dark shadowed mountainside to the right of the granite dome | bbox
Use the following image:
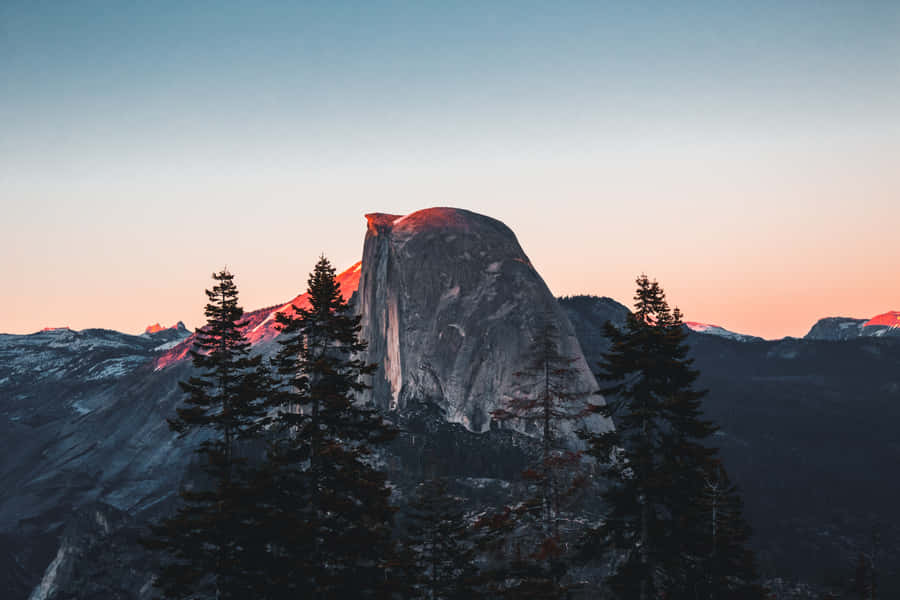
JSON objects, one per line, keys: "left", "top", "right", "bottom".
{"left": 560, "top": 297, "right": 900, "bottom": 598}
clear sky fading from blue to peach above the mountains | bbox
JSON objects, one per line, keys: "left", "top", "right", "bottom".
{"left": 0, "top": 0, "right": 900, "bottom": 338}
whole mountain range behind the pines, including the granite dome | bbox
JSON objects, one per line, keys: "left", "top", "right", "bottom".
{"left": 7, "top": 208, "right": 900, "bottom": 600}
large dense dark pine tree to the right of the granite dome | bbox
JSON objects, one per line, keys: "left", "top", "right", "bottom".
{"left": 582, "top": 275, "right": 761, "bottom": 600}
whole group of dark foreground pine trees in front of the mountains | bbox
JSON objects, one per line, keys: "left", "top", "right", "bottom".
{"left": 142, "top": 257, "right": 765, "bottom": 600}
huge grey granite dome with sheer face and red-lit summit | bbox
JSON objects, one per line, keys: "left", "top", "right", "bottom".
{"left": 357, "top": 208, "right": 609, "bottom": 432}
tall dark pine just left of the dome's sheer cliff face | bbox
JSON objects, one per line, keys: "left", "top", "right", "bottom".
{"left": 267, "top": 257, "right": 394, "bottom": 598}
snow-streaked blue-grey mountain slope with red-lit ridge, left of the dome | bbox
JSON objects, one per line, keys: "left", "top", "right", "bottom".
{"left": 0, "top": 264, "right": 359, "bottom": 600}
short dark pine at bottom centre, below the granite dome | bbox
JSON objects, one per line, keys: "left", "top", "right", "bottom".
{"left": 404, "top": 479, "right": 477, "bottom": 600}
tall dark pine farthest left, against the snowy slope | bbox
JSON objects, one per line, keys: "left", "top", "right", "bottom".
{"left": 142, "top": 269, "right": 268, "bottom": 599}
